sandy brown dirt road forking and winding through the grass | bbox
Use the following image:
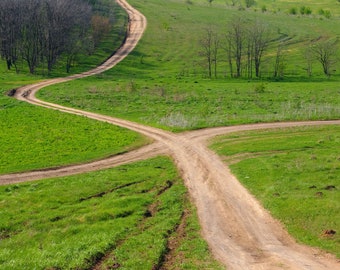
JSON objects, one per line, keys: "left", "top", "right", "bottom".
{"left": 0, "top": 0, "right": 340, "bottom": 270}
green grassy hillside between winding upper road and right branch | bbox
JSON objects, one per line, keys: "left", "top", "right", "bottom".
{"left": 38, "top": 0, "right": 340, "bottom": 131}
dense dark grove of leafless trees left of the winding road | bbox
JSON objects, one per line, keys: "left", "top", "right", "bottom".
{"left": 0, "top": 0, "right": 114, "bottom": 73}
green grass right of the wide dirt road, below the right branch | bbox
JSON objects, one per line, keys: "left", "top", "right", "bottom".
{"left": 212, "top": 126, "right": 340, "bottom": 257}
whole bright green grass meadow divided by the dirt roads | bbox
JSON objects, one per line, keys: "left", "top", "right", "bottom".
{"left": 0, "top": 0, "right": 340, "bottom": 269}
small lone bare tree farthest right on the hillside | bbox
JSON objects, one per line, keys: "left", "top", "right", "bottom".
{"left": 312, "top": 40, "right": 338, "bottom": 77}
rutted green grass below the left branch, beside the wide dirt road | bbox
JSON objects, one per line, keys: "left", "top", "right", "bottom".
{"left": 0, "top": 157, "right": 222, "bottom": 269}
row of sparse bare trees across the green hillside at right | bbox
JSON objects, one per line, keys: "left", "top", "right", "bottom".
{"left": 199, "top": 16, "right": 338, "bottom": 79}
